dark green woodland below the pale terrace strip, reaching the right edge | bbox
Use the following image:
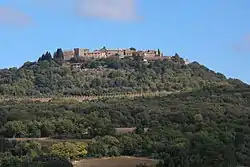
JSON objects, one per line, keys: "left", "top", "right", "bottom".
{"left": 0, "top": 85, "right": 250, "bottom": 167}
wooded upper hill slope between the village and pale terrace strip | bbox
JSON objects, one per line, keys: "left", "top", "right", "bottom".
{"left": 0, "top": 52, "right": 243, "bottom": 97}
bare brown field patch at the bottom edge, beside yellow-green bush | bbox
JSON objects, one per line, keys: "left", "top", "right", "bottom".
{"left": 74, "top": 157, "right": 158, "bottom": 167}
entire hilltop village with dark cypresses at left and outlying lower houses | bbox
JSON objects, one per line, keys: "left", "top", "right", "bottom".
{"left": 38, "top": 47, "right": 190, "bottom": 70}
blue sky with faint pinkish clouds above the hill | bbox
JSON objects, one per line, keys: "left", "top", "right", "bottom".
{"left": 0, "top": 0, "right": 250, "bottom": 83}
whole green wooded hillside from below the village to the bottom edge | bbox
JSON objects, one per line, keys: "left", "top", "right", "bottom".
{"left": 0, "top": 56, "right": 250, "bottom": 167}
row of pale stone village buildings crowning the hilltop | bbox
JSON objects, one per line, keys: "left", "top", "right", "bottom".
{"left": 63, "top": 47, "right": 171, "bottom": 61}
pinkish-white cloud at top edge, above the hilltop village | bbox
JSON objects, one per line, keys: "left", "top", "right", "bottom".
{"left": 76, "top": 0, "right": 138, "bottom": 21}
